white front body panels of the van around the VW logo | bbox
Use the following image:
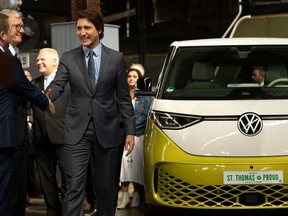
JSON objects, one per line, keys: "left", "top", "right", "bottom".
{"left": 153, "top": 99, "right": 288, "bottom": 157}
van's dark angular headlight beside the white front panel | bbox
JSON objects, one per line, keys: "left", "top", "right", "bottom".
{"left": 150, "top": 110, "right": 202, "bottom": 130}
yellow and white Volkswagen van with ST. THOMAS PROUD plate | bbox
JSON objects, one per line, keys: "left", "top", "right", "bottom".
{"left": 144, "top": 38, "right": 288, "bottom": 213}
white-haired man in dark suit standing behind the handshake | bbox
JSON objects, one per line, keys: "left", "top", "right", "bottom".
{"left": 32, "top": 48, "right": 70, "bottom": 216}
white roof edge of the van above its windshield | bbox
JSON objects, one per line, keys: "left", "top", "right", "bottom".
{"left": 170, "top": 37, "right": 288, "bottom": 47}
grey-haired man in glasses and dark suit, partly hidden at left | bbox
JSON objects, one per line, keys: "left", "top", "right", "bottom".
{"left": 0, "top": 9, "right": 28, "bottom": 216}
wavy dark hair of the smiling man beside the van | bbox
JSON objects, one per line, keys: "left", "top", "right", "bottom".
{"left": 76, "top": 9, "right": 104, "bottom": 40}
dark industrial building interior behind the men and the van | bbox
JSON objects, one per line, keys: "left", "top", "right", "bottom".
{"left": 5, "top": 0, "right": 288, "bottom": 81}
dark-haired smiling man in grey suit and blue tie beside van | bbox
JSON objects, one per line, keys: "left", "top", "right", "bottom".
{"left": 48, "top": 10, "right": 135, "bottom": 216}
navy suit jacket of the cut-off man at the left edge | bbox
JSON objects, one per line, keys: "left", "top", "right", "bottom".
{"left": 0, "top": 51, "right": 49, "bottom": 148}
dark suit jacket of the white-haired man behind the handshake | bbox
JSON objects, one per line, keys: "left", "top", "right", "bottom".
{"left": 32, "top": 76, "right": 70, "bottom": 145}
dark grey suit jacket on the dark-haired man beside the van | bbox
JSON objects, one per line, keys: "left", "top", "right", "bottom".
{"left": 48, "top": 45, "right": 135, "bottom": 148}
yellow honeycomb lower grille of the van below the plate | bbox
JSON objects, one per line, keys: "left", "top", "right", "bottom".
{"left": 155, "top": 169, "right": 288, "bottom": 209}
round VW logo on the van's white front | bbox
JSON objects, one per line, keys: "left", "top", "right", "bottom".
{"left": 238, "top": 113, "right": 263, "bottom": 136}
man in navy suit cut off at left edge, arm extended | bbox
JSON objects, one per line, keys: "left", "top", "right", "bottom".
{"left": 0, "top": 14, "right": 54, "bottom": 216}
